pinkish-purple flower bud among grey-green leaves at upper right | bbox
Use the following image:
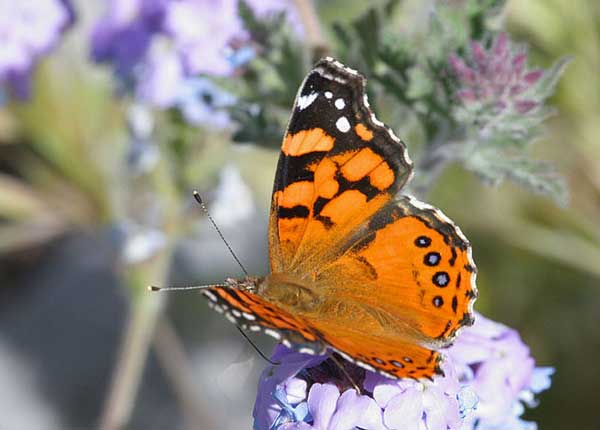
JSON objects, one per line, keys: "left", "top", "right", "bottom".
{"left": 449, "top": 33, "right": 544, "bottom": 114}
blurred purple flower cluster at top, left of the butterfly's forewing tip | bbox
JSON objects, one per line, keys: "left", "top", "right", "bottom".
{"left": 91, "top": 0, "right": 297, "bottom": 115}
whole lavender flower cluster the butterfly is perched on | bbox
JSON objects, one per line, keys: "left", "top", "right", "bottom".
{"left": 254, "top": 315, "right": 554, "bottom": 430}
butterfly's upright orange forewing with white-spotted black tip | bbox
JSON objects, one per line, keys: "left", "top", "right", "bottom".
{"left": 269, "top": 58, "right": 412, "bottom": 276}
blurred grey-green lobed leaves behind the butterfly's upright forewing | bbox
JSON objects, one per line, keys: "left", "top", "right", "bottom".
{"left": 223, "top": 0, "right": 567, "bottom": 204}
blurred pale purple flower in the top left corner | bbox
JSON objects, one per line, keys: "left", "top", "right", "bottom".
{"left": 0, "top": 0, "right": 74, "bottom": 99}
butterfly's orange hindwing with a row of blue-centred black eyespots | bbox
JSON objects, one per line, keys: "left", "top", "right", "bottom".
{"left": 305, "top": 196, "right": 477, "bottom": 378}
